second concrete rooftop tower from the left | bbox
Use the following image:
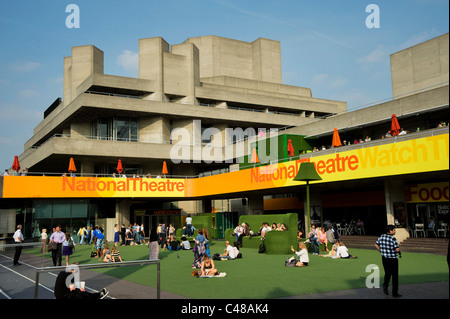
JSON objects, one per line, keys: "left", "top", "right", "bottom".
{"left": 139, "top": 37, "right": 169, "bottom": 101}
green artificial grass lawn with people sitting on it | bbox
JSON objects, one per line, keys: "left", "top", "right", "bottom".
{"left": 30, "top": 241, "right": 449, "bottom": 299}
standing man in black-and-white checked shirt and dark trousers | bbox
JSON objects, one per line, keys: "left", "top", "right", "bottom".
{"left": 375, "top": 225, "right": 402, "bottom": 297}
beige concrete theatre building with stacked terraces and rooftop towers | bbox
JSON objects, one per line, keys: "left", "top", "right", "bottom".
{"left": 0, "top": 34, "right": 449, "bottom": 242}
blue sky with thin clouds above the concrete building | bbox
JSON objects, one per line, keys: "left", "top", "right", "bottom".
{"left": 0, "top": 0, "right": 449, "bottom": 171}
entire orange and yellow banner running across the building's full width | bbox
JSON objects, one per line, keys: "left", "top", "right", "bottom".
{"left": 3, "top": 134, "right": 449, "bottom": 200}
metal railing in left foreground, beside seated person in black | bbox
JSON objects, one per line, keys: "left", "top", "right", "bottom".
{"left": 34, "top": 259, "right": 161, "bottom": 299}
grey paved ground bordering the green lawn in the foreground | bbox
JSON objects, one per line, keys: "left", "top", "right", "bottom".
{"left": 0, "top": 252, "right": 449, "bottom": 300}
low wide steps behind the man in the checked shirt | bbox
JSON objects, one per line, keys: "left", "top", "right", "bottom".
{"left": 340, "top": 236, "right": 448, "bottom": 256}
